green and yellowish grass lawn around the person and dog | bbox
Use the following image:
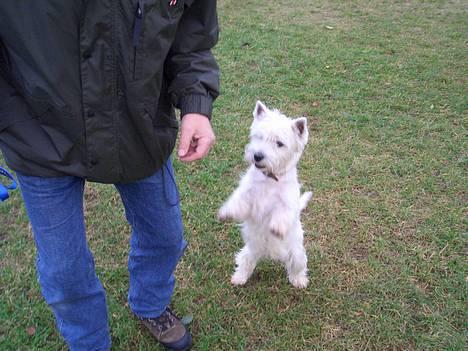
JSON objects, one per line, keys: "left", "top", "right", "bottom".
{"left": 0, "top": 0, "right": 468, "bottom": 351}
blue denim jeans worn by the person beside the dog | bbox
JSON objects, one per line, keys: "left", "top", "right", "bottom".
{"left": 17, "top": 161, "right": 186, "bottom": 351}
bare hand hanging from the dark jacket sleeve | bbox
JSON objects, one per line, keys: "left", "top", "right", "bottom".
{"left": 177, "top": 113, "right": 215, "bottom": 162}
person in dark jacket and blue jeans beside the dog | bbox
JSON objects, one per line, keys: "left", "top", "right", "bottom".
{"left": 0, "top": 0, "right": 219, "bottom": 351}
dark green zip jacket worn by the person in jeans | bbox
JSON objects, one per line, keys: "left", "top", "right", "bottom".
{"left": 0, "top": 0, "right": 219, "bottom": 183}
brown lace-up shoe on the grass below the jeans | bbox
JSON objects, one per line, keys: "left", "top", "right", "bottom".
{"left": 138, "top": 307, "right": 192, "bottom": 351}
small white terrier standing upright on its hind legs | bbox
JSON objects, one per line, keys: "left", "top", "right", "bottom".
{"left": 218, "top": 101, "right": 312, "bottom": 288}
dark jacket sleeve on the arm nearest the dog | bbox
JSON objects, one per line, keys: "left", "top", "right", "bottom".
{"left": 165, "top": 0, "right": 219, "bottom": 118}
